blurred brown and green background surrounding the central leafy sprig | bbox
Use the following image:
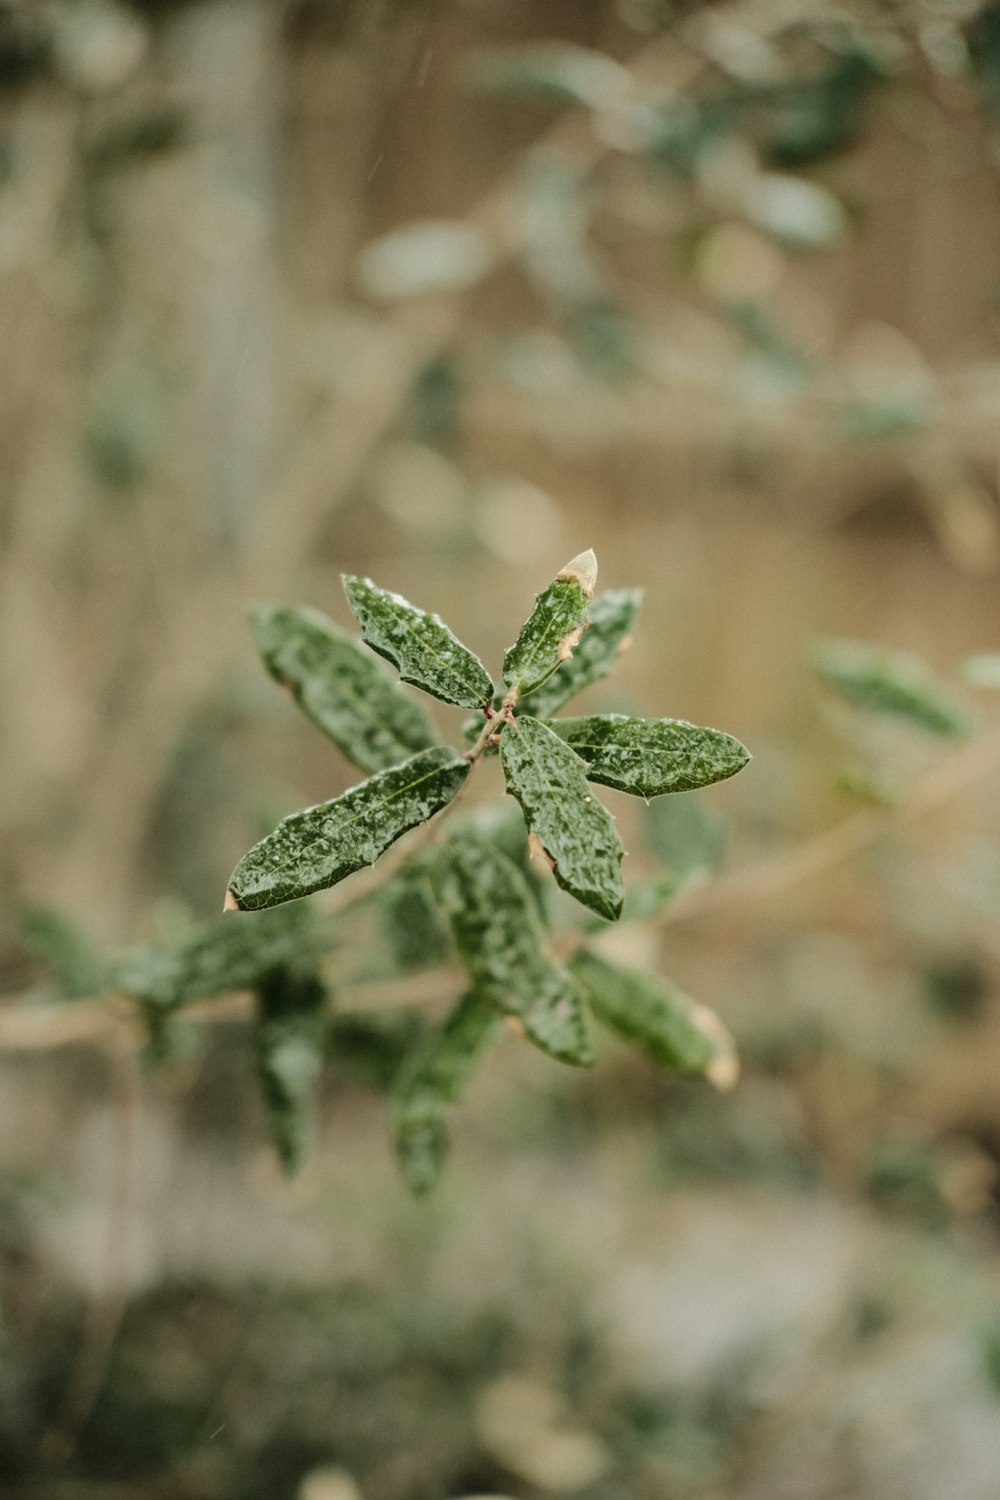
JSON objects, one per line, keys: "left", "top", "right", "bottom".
{"left": 0, "top": 0, "right": 1000, "bottom": 1500}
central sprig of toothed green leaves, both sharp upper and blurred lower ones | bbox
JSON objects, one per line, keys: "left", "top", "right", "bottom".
{"left": 117, "top": 552, "right": 748, "bottom": 1190}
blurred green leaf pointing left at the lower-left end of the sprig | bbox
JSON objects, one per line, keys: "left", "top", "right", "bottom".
{"left": 109, "top": 906, "right": 312, "bottom": 1010}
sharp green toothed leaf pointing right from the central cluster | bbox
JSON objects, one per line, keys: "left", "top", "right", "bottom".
{"left": 549, "top": 714, "right": 750, "bottom": 801}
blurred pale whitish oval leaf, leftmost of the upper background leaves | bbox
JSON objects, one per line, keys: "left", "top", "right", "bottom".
{"left": 357, "top": 219, "right": 493, "bottom": 302}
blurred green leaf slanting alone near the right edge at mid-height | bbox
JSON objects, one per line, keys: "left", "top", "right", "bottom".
{"left": 813, "top": 641, "right": 972, "bottom": 738}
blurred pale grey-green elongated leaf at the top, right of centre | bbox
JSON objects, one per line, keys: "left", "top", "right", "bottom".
{"left": 471, "top": 42, "right": 633, "bottom": 110}
